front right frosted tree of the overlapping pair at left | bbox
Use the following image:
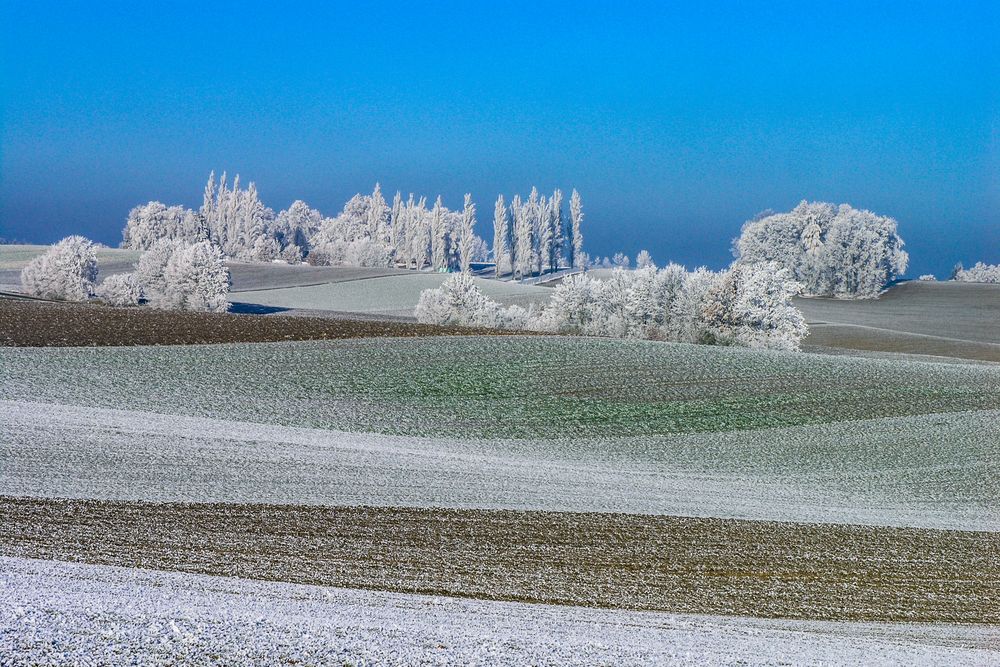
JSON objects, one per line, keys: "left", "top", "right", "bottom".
{"left": 163, "top": 241, "right": 230, "bottom": 313}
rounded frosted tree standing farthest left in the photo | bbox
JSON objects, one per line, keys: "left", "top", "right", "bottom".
{"left": 21, "top": 236, "right": 97, "bottom": 301}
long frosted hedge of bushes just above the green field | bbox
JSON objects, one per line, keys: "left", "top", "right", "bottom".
{"left": 416, "top": 263, "right": 807, "bottom": 350}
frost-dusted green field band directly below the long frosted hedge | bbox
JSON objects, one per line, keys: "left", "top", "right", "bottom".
{"left": 0, "top": 336, "right": 1000, "bottom": 439}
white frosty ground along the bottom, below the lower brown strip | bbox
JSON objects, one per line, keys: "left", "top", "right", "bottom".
{"left": 0, "top": 558, "right": 1000, "bottom": 667}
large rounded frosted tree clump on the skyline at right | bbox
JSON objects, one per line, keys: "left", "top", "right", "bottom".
{"left": 734, "top": 201, "right": 909, "bottom": 298}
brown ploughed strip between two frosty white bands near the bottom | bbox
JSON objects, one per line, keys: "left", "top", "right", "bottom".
{"left": 0, "top": 497, "right": 1000, "bottom": 623}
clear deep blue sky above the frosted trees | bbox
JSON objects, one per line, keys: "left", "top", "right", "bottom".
{"left": 0, "top": 0, "right": 1000, "bottom": 275}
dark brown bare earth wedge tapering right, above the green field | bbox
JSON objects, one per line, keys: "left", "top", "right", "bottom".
{"left": 0, "top": 298, "right": 502, "bottom": 347}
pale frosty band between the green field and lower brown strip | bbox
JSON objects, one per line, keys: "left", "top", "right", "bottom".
{"left": 0, "top": 401, "right": 1000, "bottom": 530}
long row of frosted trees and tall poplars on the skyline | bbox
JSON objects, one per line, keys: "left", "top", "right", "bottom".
{"left": 122, "top": 172, "right": 587, "bottom": 278}
